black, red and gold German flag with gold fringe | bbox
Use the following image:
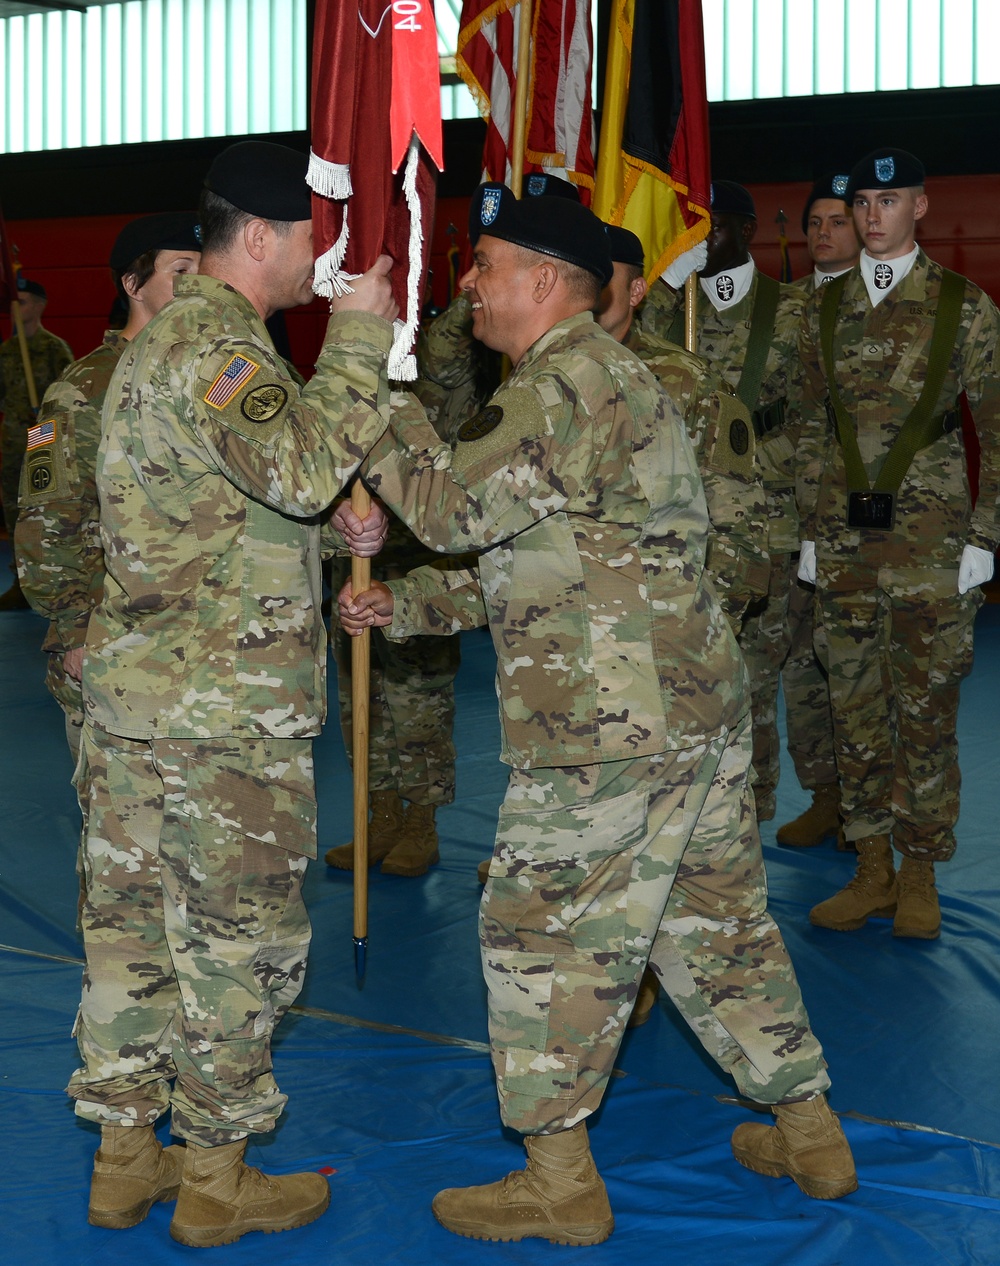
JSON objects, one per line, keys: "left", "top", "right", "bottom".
{"left": 594, "top": 0, "right": 711, "bottom": 279}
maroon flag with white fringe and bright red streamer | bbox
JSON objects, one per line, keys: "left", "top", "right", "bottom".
{"left": 309, "top": 0, "right": 443, "bottom": 379}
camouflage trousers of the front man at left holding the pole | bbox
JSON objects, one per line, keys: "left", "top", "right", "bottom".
{"left": 68, "top": 724, "right": 316, "bottom": 1146}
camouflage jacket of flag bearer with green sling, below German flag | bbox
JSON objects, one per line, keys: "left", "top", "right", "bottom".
{"left": 639, "top": 273, "right": 804, "bottom": 553}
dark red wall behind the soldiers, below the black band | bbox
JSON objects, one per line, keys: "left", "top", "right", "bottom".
{"left": 3, "top": 175, "right": 1000, "bottom": 371}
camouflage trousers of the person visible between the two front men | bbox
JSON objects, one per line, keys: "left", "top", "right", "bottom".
{"left": 335, "top": 617, "right": 461, "bottom": 805}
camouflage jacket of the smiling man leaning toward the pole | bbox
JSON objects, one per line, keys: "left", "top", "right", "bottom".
{"left": 366, "top": 314, "right": 748, "bottom": 767}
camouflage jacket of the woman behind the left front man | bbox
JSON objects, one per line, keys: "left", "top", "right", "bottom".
{"left": 16, "top": 329, "right": 127, "bottom": 651}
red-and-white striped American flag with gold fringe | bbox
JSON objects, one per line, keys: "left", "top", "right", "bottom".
{"left": 456, "top": 0, "right": 594, "bottom": 204}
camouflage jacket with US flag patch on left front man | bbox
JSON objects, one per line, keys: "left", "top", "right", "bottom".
{"left": 84, "top": 276, "right": 391, "bottom": 738}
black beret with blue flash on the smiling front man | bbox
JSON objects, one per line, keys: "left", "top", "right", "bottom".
{"left": 468, "top": 184, "right": 614, "bottom": 286}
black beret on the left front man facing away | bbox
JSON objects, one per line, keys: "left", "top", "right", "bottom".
{"left": 205, "top": 141, "right": 313, "bottom": 220}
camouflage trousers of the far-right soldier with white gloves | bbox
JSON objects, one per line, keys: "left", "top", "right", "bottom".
{"left": 815, "top": 568, "right": 982, "bottom": 861}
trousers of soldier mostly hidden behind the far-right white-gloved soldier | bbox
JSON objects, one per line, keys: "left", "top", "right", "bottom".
{"left": 781, "top": 572, "right": 837, "bottom": 791}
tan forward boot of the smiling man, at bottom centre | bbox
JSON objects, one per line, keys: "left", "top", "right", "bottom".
{"left": 432, "top": 1122, "right": 615, "bottom": 1244}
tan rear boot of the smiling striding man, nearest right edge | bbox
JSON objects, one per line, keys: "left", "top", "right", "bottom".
{"left": 733, "top": 1095, "right": 858, "bottom": 1200}
